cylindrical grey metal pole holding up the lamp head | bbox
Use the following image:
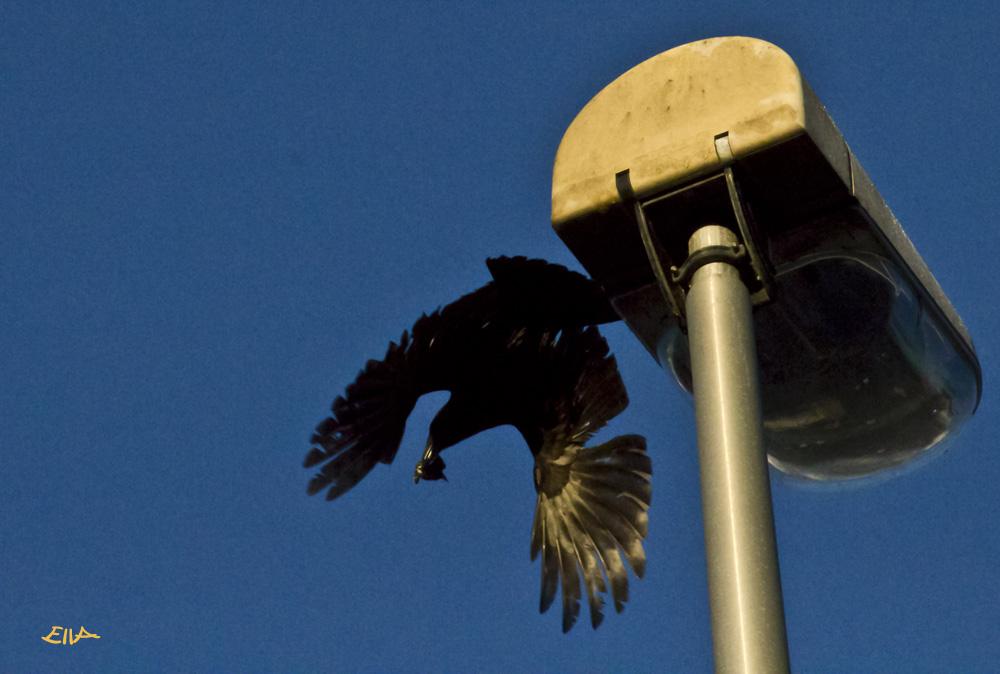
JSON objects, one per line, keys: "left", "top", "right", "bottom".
{"left": 686, "top": 225, "right": 790, "bottom": 674}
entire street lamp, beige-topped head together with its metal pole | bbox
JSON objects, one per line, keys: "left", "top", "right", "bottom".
{"left": 552, "top": 37, "right": 982, "bottom": 672}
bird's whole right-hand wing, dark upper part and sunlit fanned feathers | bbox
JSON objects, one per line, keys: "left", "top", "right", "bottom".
{"left": 531, "top": 329, "right": 653, "bottom": 632}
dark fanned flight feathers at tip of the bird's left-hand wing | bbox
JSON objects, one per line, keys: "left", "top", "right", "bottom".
{"left": 304, "top": 332, "right": 417, "bottom": 501}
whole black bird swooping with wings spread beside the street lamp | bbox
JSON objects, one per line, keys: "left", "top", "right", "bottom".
{"left": 305, "top": 257, "right": 652, "bottom": 632}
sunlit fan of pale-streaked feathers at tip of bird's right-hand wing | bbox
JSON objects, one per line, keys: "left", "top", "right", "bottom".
{"left": 531, "top": 435, "right": 653, "bottom": 632}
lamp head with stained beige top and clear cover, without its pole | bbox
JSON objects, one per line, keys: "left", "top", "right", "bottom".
{"left": 552, "top": 37, "right": 982, "bottom": 480}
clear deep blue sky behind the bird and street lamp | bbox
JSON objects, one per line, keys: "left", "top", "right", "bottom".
{"left": 0, "top": 0, "right": 1000, "bottom": 672}
